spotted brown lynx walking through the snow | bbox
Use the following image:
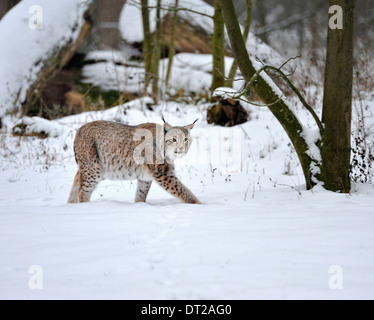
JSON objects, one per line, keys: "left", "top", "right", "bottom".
{"left": 68, "top": 120, "right": 200, "bottom": 204}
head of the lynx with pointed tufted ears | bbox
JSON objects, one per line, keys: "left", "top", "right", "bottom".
{"left": 162, "top": 118, "right": 197, "bottom": 160}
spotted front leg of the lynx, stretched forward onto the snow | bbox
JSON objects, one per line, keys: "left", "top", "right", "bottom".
{"left": 155, "top": 175, "right": 201, "bottom": 204}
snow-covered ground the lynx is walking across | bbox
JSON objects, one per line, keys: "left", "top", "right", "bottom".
{"left": 0, "top": 99, "right": 374, "bottom": 299}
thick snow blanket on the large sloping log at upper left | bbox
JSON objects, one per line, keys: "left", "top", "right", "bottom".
{"left": 0, "top": 0, "right": 91, "bottom": 118}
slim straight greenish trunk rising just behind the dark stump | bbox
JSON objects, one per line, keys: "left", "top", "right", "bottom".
{"left": 211, "top": 0, "right": 225, "bottom": 97}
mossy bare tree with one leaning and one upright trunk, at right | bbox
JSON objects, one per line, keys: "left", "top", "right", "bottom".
{"left": 219, "top": 0, "right": 355, "bottom": 192}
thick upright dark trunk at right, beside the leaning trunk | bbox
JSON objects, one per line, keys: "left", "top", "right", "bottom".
{"left": 322, "top": 0, "right": 355, "bottom": 192}
